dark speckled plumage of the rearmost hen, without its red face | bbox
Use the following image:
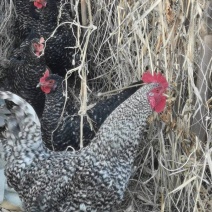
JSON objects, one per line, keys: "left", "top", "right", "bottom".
{"left": 14, "top": 0, "right": 79, "bottom": 76}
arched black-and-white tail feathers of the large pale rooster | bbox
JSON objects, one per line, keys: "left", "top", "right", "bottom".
{"left": 0, "top": 91, "right": 48, "bottom": 189}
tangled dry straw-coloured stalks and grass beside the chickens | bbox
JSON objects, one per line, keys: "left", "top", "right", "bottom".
{"left": 0, "top": 0, "right": 212, "bottom": 212}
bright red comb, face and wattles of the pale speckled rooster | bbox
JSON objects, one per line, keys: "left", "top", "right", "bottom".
{"left": 142, "top": 71, "right": 168, "bottom": 113}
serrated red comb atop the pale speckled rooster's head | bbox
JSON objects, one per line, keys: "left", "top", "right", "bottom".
{"left": 141, "top": 71, "right": 168, "bottom": 89}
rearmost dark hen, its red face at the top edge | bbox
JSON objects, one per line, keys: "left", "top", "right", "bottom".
{"left": 30, "top": 0, "right": 79, "bottom": 76}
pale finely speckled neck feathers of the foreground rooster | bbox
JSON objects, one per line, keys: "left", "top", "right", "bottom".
{"left": 82, "top": 84, "right": 157, "bottom": 164}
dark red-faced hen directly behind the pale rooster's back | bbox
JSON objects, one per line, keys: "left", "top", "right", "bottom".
{"left": 39, "top": 71, "right": 141, "bottom": 151}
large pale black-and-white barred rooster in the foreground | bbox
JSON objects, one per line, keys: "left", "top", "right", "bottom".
{"left": 0, "top": 73, "right": 168, "bottom": 212}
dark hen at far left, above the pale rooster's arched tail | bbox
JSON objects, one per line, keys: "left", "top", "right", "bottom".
{"left": 1, "top": 33, "right": 46, "bottom": 117}
